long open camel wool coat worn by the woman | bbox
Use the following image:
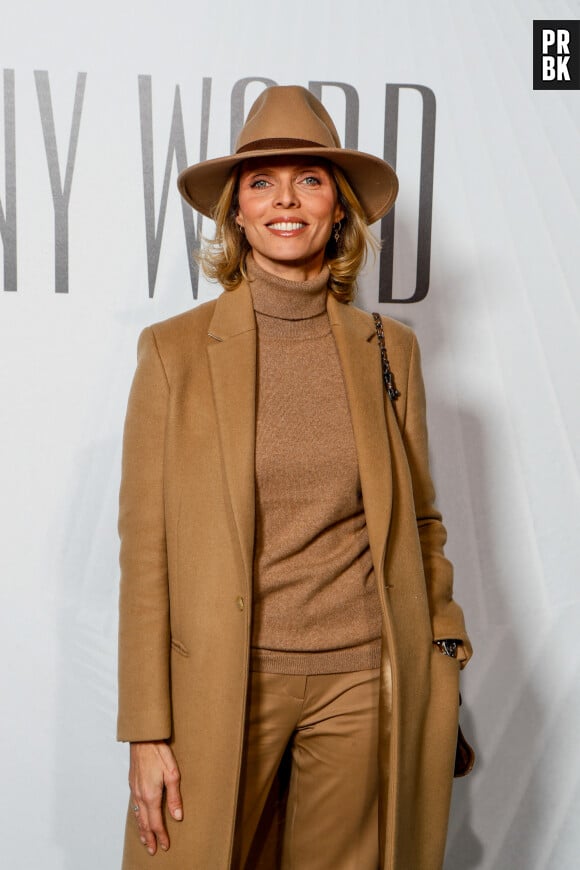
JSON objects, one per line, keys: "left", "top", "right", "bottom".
{"left": 118, "top": 283, "right": 471, "bottom": 870}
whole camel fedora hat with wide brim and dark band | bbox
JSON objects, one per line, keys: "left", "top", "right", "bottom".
{"left": 177, "top": 85, "right": 399, "bottom": 224}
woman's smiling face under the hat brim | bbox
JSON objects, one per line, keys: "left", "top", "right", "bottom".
{"left": 236, "top": 157, "right": 344, "bottom": 281}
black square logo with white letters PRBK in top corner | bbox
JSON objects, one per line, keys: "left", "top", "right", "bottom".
{"left": 534, "top": 21, "right": 580, "bottom": 91}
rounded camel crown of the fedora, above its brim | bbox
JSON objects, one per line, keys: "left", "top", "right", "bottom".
{"left": 235, "top": 85, "right": 341, "bottom": 153}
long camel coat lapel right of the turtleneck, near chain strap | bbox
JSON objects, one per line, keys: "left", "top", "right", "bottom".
{"left": 327, "top": 294, "right": 392, "bottom": 578}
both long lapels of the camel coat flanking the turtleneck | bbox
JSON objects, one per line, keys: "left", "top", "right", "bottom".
{"left": 208, "top": 282, "right": 392, "bottom": 589}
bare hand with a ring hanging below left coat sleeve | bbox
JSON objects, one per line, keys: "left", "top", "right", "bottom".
{"left": 129, "top": 740, "right": 183, "bottom": 855}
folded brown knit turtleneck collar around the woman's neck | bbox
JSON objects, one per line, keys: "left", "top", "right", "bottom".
{"left": 246, "top": 255, "right": 330, "bottom": 320}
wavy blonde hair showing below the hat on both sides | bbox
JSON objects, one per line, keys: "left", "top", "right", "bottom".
{"left": 197, "top": 160, "right": 380, "bottom": 303}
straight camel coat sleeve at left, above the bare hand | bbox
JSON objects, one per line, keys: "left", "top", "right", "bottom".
{"left": 117, "top": 327, "right": 171, "bottom": 741}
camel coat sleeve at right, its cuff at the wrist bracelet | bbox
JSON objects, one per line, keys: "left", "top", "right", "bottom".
{"left": 402, "top": 336, "right": 472, "bottom": 665}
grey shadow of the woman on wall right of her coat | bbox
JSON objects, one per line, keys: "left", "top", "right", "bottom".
{"left": 408, "top": 262, "right": 547, "bottom": 870}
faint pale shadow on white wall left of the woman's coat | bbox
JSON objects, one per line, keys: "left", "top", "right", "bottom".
{"left": 52, "top": 441, "right": 128, "bottom": 870}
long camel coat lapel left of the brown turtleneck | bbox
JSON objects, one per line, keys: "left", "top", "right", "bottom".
{"left": 208, "top": 283, "right": 256, "bottom": 588}
